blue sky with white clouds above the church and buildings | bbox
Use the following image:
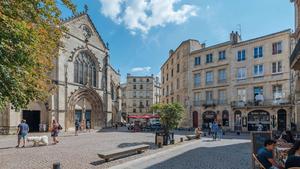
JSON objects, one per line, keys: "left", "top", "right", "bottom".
{"left": 63, "top": 0, "right": 294, "bottom": 82}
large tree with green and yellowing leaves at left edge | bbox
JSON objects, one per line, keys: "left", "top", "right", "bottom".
{"left": 0, "top": 0, "right": 76, "bottom": 110}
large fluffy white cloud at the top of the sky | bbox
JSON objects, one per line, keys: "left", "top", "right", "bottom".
{"left": 99, "top": 0, "right": 197, "bottom": 35}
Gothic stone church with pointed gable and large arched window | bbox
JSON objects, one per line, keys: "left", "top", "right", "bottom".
{"left": 0, "top": 11, "right": 121, "bottom": 134}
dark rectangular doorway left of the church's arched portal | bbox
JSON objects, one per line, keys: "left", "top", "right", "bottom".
{"left": 22, "top": 110, "right": 41, "bottom": 132}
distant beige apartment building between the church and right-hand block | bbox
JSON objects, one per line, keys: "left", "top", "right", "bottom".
{"left": 121, "top": 74, "right": 160, "bottom": 116}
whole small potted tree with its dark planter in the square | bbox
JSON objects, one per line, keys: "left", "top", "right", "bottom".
{"left": 151, "top": 103, "right": 184, "bottom": 145}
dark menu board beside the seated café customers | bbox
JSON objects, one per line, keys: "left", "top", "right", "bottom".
{"left": 251, "top": 131, "right": 272, "bottom": 154}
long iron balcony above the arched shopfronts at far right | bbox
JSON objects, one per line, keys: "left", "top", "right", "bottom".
{"left": 231, "top": 98, "right": 291, "bottom": 108}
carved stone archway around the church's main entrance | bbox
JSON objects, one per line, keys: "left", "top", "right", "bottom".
{"left": 65, "top": 87, "right": 106, "bottom": 130}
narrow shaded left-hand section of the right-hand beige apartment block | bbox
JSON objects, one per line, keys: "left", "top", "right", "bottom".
{"left": 161, "top": 39, "right": 201, "bottom": 127}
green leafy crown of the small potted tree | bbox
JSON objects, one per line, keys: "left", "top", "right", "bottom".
{"left": 151, "top": 103, "right": 184, "bottom": 133}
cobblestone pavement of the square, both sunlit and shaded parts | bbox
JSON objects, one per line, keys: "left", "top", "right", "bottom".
{"left": 0, "top": 129, "right": 250, "bottom": 169}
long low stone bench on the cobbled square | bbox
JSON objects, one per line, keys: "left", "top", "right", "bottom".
{"left": 98, "top": 144, "right": 150, "bottom": 162}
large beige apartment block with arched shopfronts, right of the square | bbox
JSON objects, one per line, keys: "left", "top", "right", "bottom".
{"left": 161, "top": 30, "right": 295, "bottom": 131}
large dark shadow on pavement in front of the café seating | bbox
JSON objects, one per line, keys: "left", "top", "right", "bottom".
{"left": 147, "top": 143, "right": 251, "bottom": 169}
